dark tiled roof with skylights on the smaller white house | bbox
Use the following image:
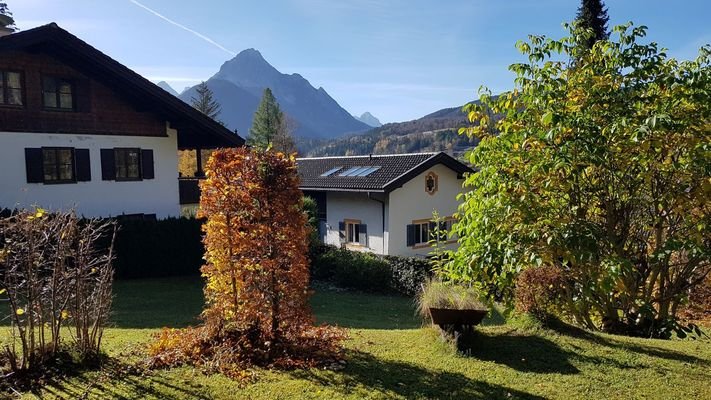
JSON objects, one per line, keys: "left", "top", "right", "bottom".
{"left": 296, "top": 153, "right": 472, "bottom": 192}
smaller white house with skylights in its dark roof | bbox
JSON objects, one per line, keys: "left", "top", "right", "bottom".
{"left": 297, "top": 153, "right": 472, "bottom": 256}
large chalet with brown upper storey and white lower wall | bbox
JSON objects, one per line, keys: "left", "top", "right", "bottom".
{"left": 0, "top": 23, "right": 244, "bottom": 218}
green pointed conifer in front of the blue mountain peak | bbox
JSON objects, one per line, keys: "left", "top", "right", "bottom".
{"left": 247, "top": 88, "right": 296, "bottom": 153}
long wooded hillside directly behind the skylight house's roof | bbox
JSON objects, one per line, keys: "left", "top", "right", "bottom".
{"left": 297, "top": 107, "right": 478, "bottom": 157}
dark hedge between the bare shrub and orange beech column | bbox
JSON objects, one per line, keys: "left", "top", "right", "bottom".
{"left": 114, "top": 218, "right": 205, "bottom": 278}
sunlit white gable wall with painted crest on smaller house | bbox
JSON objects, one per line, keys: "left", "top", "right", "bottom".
{"left": 388, "top": 164, "right": 463, "bottom": 256}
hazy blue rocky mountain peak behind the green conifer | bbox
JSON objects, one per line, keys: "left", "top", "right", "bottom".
{"left": 179, "top": 49, "right": 370, "bottom": 139}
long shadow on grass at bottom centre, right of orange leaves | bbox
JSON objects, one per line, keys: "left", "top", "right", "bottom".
{"left": 290, "top": 350, "right": 543, "bottom": 399}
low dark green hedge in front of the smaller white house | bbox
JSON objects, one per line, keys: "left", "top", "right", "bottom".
{"left": 311, "top": 246, "right": 431, "bottom": 296}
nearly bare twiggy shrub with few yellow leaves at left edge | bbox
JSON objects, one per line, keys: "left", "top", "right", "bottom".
{"left": 0, "top": 209, "right": 116, "bottom": 381}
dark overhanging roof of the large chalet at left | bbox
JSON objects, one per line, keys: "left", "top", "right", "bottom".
{"left": 0, "top": 23, "right": 244, "bottom": 148}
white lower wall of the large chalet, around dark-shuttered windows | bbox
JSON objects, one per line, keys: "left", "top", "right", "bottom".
{"left": 0, "top": 128, "right": 180, "bottom": 218}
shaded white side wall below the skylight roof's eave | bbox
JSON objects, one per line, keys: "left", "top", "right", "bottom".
{"left": 325, "top": 192, "right": 387, "bottom": 254}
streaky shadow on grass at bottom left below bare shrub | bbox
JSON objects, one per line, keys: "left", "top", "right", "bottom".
{"left": 31, "top": 358, "right": 207, "bottom": 399}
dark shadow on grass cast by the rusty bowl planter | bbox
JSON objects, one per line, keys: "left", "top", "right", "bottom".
{"left": 458, "top": 330, "right": 580, "bottom": 375}
